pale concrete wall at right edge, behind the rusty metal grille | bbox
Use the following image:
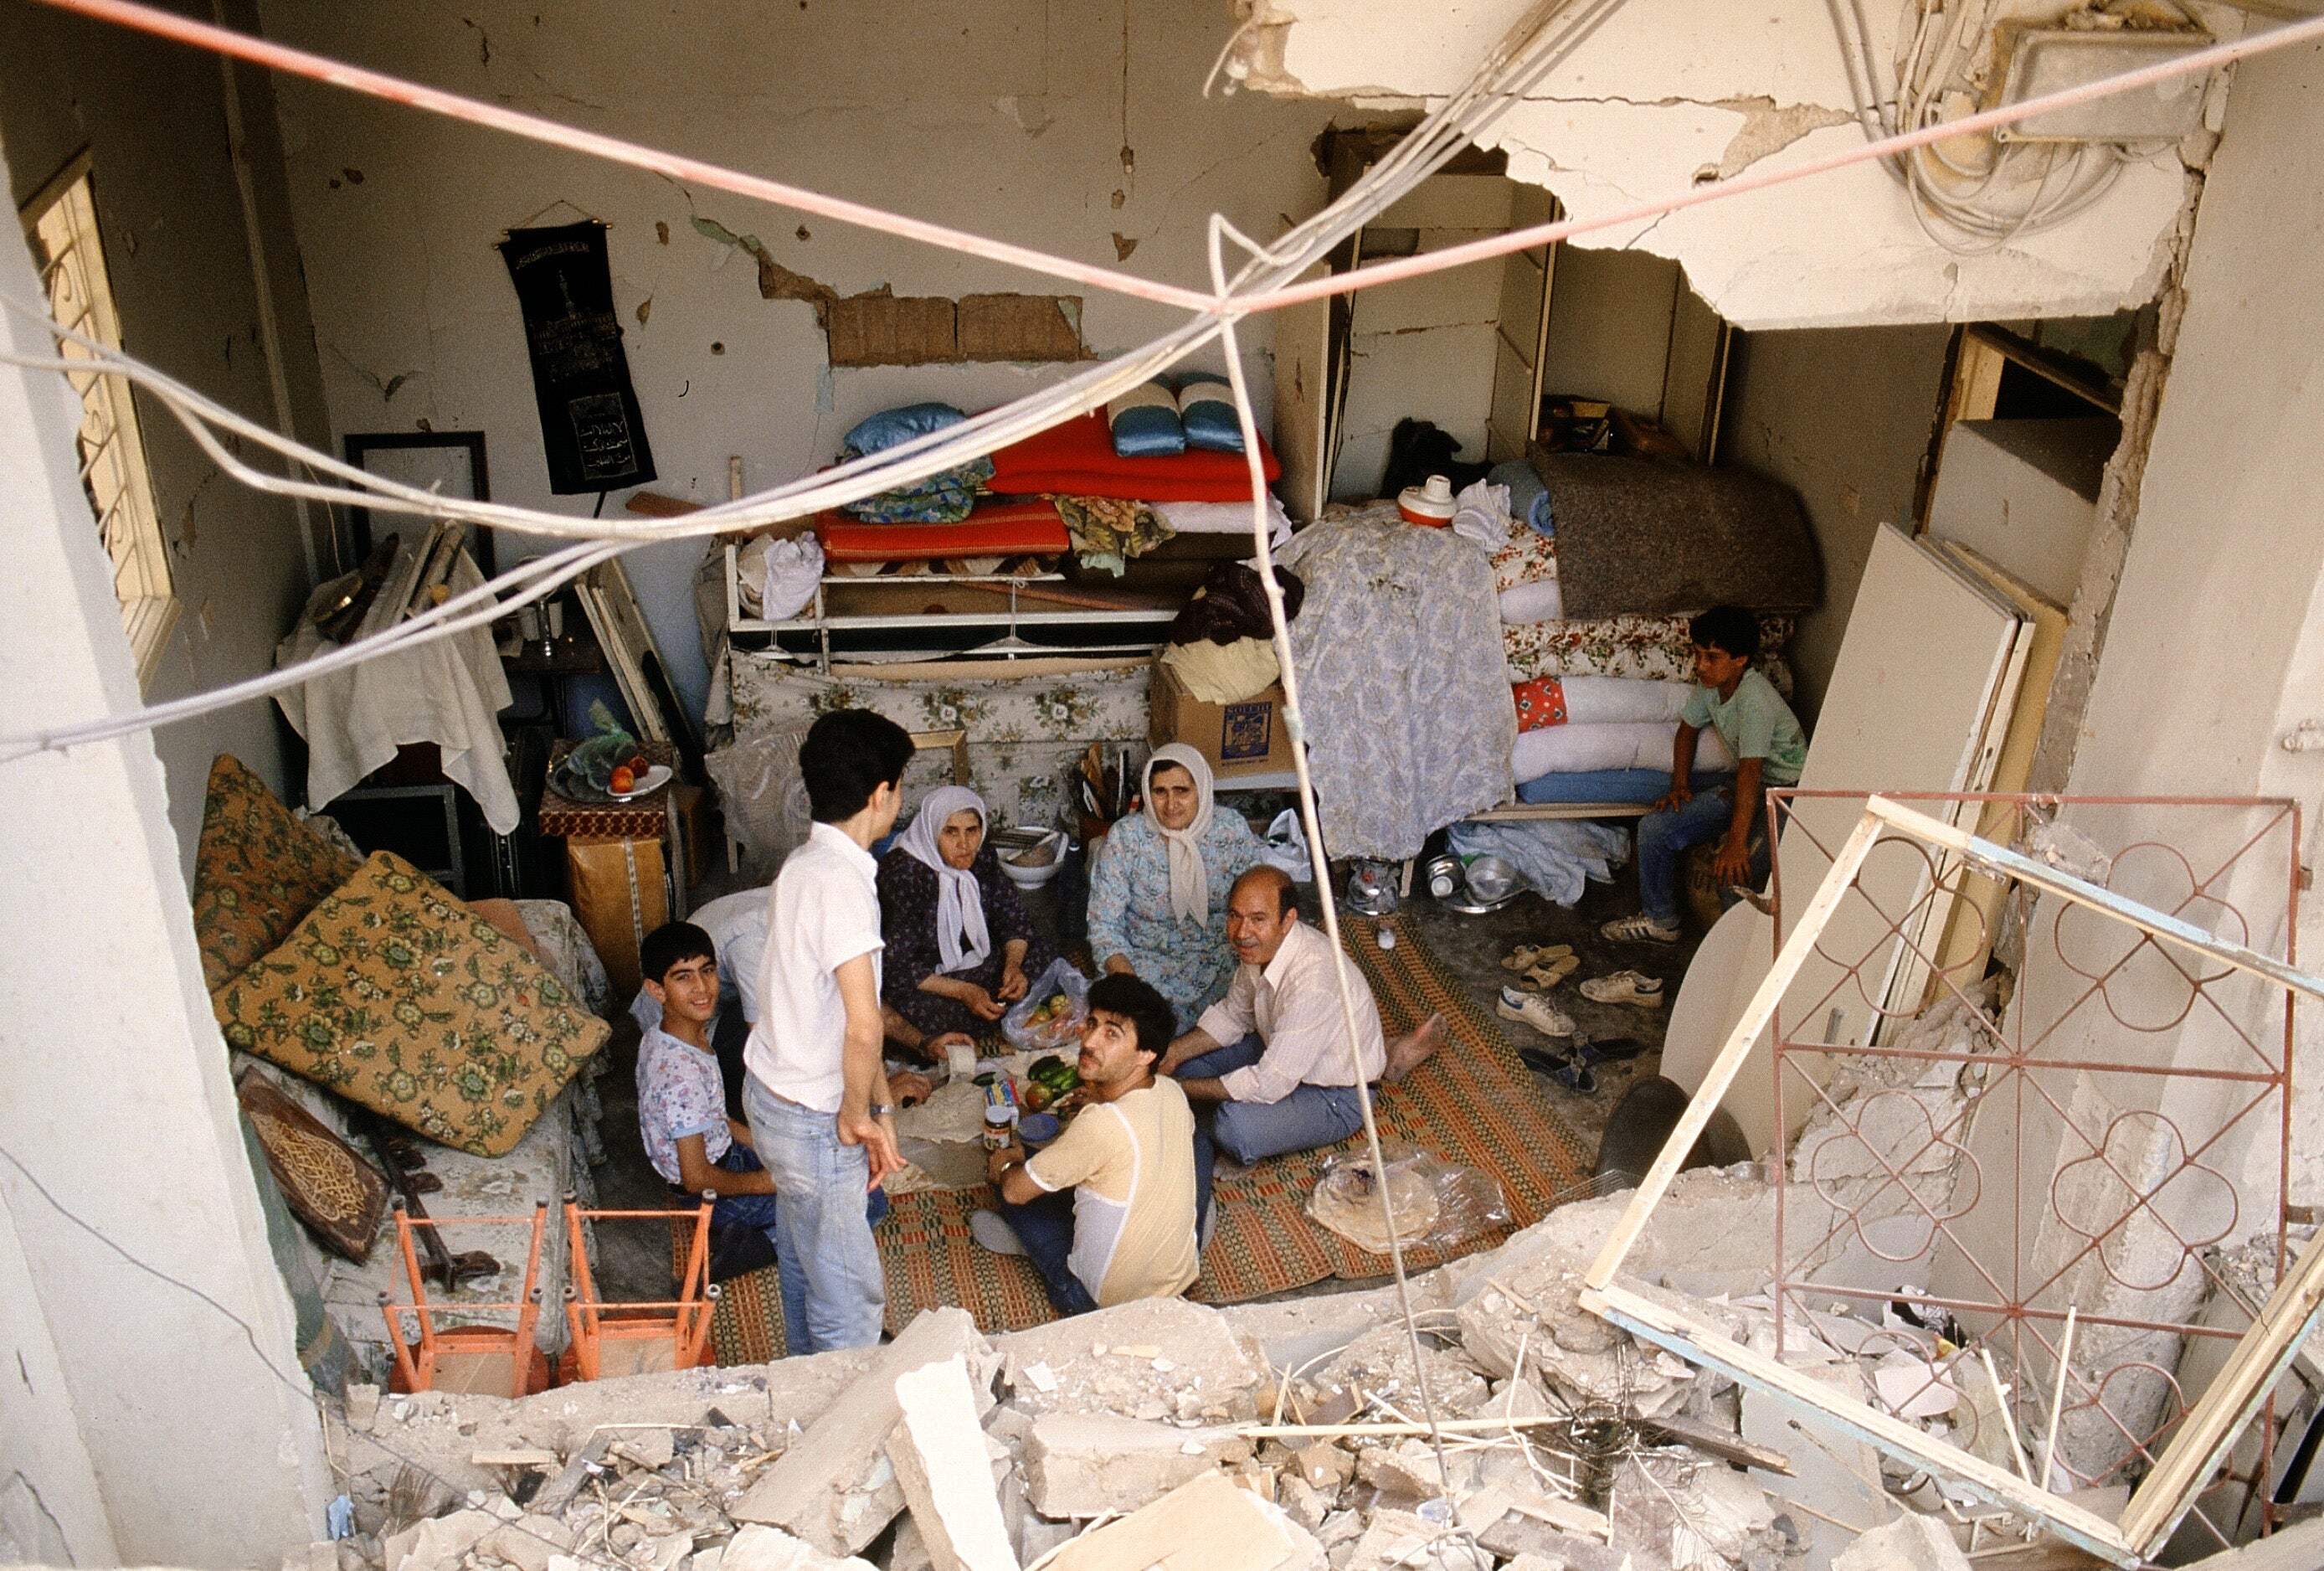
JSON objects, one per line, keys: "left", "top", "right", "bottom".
{"left": 1980, "top": 37, "right": 2324, "bottom": 1487}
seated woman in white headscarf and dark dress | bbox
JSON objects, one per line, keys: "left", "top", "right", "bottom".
{"left": 878, "top": 786, "right": 1051, "bottom": 1046}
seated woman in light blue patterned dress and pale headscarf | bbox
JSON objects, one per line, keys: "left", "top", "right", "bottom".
{"left": 1090, "top": 741, "right": 1260, "bottom": 1032}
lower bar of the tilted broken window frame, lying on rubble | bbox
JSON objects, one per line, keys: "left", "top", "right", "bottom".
{"left": 1581, "top": 1282, "right": 2152, "bottom": 1566}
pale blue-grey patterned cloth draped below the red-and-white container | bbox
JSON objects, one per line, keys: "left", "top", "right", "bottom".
{"left": 1281, "top": 504, "right": 1518, "bottom": 858}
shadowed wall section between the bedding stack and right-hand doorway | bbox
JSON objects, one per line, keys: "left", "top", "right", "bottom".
{"left": 1720, "top": 327, "right": 1950, "bottom": 725}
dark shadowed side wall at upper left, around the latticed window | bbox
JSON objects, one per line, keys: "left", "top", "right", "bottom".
{"left": 0, "top": 0, "right": 337, "bottom": 873}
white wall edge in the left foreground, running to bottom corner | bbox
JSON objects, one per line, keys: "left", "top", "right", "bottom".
{"left": 0, "top": 131, "right": 332, "bottom": 1566}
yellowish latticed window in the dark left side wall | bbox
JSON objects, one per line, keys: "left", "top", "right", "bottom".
{"left": 18, "top": 149, "right": 179, "bottom": 690}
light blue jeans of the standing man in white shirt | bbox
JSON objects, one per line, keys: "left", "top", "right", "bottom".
{"left": 742, "top": 1076, "right": 887, "bottom": 1352}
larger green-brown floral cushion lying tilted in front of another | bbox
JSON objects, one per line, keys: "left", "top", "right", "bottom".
{"left": 212, "top": 851, "right": 611, "bottom": 1157}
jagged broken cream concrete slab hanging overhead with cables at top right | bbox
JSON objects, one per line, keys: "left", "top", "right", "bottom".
{"left": 1239, "top": 0, "right": 2240, "bottom": 327}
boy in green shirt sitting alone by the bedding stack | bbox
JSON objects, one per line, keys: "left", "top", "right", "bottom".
{"left": 1599, "top": 606, "right": 1808, "bottom": 944}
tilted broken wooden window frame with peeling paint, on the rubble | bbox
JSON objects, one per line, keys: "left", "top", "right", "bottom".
{"left": 1581, "top": 795, "right": 2324, "bottom": 1566}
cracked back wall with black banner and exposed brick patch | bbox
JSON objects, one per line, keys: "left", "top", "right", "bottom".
{"left": 263, "top": 0, "right": 1332, "bottom": 720}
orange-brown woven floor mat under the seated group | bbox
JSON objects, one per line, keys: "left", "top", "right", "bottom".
{"left": 687, "top": 915, "right": 1590, "bottom": 1364}
